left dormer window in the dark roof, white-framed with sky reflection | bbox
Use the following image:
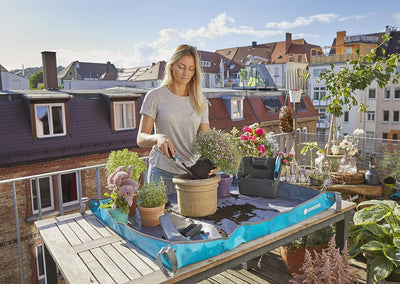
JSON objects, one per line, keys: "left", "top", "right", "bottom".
{"left": 35, "top": 103, "right": 66, "bottom": 138}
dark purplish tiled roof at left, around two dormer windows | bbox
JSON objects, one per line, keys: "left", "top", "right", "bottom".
{"left": 0, "top": 87, "right": 148, "bottom": 168}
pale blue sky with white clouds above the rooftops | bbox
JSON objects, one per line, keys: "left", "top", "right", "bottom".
{"left": 0, "top": 0, "right": 400, "bottom": 70}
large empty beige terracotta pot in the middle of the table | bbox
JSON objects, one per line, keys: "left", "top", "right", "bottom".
{"left": 172, "top": 174, "right": 221, "bottom": 217}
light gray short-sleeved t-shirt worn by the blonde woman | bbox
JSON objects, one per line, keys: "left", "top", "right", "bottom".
{"left": 140, "top": 86, "right": 208, "bottom": 174}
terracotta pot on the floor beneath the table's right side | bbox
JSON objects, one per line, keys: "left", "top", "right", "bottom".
{"left": 279, "top": 245, "right": 328, "bottom": 274}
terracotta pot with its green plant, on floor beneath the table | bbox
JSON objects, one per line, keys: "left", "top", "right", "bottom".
{"left": 279, "top": 226, "right": 334, "bottom": 273}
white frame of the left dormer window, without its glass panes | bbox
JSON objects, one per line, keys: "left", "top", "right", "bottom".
{"left": 33, "top": 102, "right": 67, "bottom": 138}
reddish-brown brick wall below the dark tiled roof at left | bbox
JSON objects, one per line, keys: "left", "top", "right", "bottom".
{"left": 0, "top": 149, "right": 149, "bottom": 283}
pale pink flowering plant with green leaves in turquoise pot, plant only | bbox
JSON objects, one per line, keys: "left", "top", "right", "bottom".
{"left": 100, "top": 165, "right": 139, "bottom": 214}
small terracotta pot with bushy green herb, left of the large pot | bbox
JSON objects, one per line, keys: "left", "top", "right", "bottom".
{"left": 138, "top": 178, "right": 168, "bottom": 227}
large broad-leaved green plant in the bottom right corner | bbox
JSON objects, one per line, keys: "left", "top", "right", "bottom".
{"left": 349, "top": 200, "right": 400, "bottom": 282}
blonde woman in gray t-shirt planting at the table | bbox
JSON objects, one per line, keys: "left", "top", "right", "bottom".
{"left": 137, "top": 45, "right": 210, "bottom": 193}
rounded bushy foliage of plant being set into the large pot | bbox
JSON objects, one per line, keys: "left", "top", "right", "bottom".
{"left": 193, "top": 129, "right": 241, "bottom": 174}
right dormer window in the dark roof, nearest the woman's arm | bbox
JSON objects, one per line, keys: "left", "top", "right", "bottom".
{"left": 114, "top": 101, "right": 136, "bottom": 130}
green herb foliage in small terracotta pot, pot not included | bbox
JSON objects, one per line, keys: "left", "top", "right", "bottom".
{"left": 138, "top": 178, "right": 168, "bottom": 208}
